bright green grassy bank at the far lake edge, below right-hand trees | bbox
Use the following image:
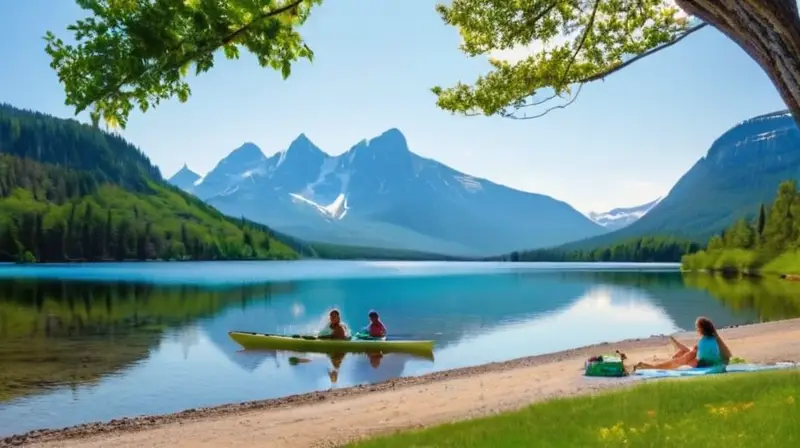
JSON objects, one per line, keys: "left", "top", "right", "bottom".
{"left": 681, "top": 249, "right": 800, "bottom": 275}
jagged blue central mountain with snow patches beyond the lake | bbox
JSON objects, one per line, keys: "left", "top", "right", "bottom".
{"left": 170, "top": 129, "right": 606, "bottom": 255}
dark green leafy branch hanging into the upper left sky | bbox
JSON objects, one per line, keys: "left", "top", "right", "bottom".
{"left": 45, "top": 0, "right": 322, "bottom": 128}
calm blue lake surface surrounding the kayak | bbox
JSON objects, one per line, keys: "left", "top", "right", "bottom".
{"left": 0, "top": 261, "right": 800, "bottom": 436}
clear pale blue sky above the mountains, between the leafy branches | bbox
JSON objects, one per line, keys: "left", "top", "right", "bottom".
{"left": 0, "top": 0, "right": 785, "bottom": 212}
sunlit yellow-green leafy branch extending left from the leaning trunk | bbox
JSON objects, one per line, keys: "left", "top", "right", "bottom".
{"left": 433, "top": 0, "right": 705, "bottom": 119}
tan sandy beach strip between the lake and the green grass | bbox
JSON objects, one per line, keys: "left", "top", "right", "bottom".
{"left": 6, "top": 319, "right": 800, "bottom": 448}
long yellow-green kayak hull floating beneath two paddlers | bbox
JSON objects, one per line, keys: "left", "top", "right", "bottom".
{"left": 228, "top": 331, "right": 433, "bottom": 357}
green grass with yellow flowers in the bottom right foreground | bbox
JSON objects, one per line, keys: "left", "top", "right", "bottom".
{"left": 349, "top": 371, "right": 800, "bottom": 448}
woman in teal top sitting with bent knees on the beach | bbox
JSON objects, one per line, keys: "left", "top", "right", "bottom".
{"left": 635, "top": 317, "right": 731, "bottom": 369}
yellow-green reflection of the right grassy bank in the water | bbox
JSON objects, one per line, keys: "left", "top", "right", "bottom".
{"left": 683, "top": 273, "right": 800, "bottom": 322}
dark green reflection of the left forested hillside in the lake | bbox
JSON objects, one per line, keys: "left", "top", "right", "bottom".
{"left": 0, "top": 280, "right": 291, "bottom": 401}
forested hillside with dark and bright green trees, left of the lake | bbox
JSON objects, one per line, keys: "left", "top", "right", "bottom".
{"left": 0, "top": 105, "right": 310, "bottom": 262}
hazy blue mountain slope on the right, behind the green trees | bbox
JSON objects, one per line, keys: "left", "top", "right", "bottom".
{"left": 559, "top": 110, "right": 800, "bottom": 250}
